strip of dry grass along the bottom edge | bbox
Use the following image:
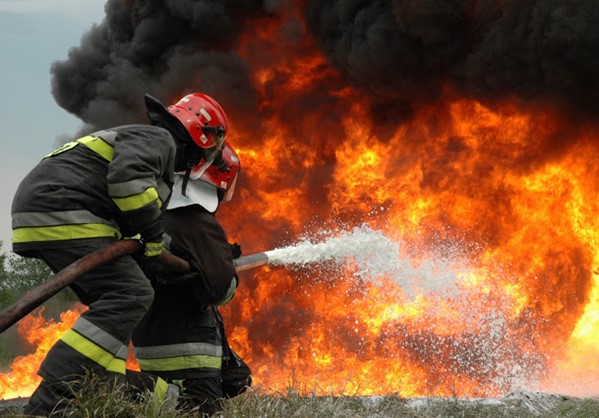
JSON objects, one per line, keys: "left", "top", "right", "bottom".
{"left": 0, "top": 379, "right": 599, "bottom": 418}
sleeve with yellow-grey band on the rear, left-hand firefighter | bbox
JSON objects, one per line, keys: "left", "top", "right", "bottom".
{"left": 107, "top": 125, "right": 175, "bottom": 239}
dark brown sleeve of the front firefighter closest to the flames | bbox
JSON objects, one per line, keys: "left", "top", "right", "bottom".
{"left": 164, "top": 205, "right": 238, "bottom": 305}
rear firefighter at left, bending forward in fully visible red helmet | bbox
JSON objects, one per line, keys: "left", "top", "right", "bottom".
{"left": 12, "top": 93, "right": 232, "bottom": 415}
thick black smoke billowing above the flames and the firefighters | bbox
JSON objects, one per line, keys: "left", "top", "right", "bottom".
{"left": 51, "top": 0, "right": 599, "bottom": 132}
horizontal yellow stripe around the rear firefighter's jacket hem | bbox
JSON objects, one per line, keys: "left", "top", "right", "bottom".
{"left": 12, "top": 224, "right": 121, "bottom": 243}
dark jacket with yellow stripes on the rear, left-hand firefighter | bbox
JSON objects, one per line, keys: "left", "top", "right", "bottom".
{"left": 12, "top": 125, "right": 176, "bottom": 256}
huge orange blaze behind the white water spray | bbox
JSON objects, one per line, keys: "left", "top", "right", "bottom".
{"left": 0, "top": 1, "right": 599, "bottom": 404}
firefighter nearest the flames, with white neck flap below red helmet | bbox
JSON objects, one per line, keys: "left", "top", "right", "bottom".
{"left": 133, "top": 143, "right": 251, "bottom": 415}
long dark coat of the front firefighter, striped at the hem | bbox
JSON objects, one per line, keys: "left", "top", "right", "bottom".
{"left": 133, "top": 205, "right": 237, "bottom": 379}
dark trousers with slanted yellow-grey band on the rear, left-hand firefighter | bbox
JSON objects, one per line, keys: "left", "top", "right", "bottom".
{"left": 25, "top": 241, "right": 154, "bottom": 415}
